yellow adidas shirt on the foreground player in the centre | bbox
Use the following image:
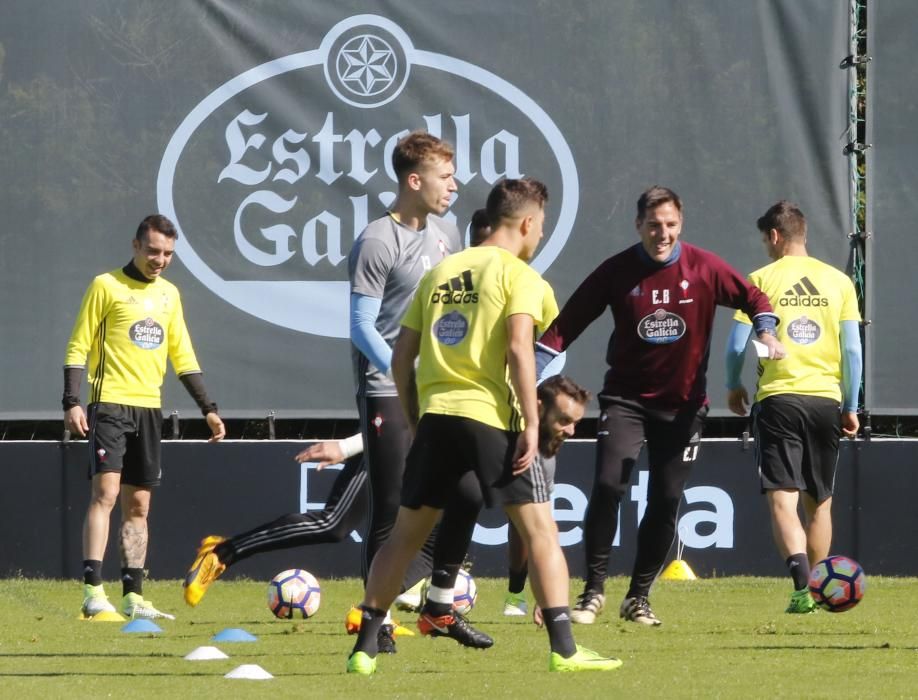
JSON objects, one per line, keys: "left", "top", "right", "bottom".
{"left": 402, "top": 246, "right": 558, "bottom": 431}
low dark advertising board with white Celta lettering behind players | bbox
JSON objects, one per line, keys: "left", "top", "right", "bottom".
{"left": 0, "top": 440, "right": 918, "bottom": 580}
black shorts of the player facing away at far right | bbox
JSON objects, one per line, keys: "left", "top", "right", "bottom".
{"left": 752, "top": 394, "right": 841, "bottom": 503}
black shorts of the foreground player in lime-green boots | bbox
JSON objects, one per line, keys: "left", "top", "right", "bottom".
{"left": 402, "top": 413, "right": 518, "bottom": 510}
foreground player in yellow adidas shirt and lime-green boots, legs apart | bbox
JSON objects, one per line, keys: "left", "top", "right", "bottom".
{"left": 347, "top": 178, "right": 621, "bottom": 675}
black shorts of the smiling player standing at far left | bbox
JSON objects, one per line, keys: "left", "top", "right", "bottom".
{"left": 88, "top": 403, "right": 163, "bottom": 488}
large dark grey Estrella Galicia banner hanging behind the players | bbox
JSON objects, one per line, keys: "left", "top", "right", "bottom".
{"left": 0, "top": 0, "right": 848, "bottom": 418}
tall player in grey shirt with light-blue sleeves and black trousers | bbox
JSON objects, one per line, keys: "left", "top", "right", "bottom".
{"left": 348, "top": 131, "right": 462, "bottom": 651}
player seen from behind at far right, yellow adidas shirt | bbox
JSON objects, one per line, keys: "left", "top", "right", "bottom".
{"left": 726, "top": 200, "right": 863, "bottom": 613}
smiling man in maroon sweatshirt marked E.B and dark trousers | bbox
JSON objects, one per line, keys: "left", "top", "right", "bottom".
{"left": 538, "top": 186, "right": 784, "bottom": 625}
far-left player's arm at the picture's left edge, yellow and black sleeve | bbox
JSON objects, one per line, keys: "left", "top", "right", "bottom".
{"left": 61, "top": 277, "right": 109, "bottom": 437}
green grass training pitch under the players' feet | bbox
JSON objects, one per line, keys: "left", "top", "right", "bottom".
{"left": 0, "top": 577, "right": 918, "bottom": 700}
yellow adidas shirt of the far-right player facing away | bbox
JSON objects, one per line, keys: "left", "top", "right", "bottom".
{"left": 733, "top": 255, "right": 861, "bottom": 401}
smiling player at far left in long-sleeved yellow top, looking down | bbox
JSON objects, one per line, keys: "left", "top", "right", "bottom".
{"left": 62, "top": 215, "right": 226, "bottom": 619}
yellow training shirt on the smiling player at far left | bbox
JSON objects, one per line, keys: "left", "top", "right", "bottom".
{"left": 64, "top": 270, "right": 201, "bottom": 408}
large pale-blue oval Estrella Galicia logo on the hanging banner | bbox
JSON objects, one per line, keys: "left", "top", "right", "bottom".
{"left": 157, "top": 14, "right": 580, "bottom": 338}
